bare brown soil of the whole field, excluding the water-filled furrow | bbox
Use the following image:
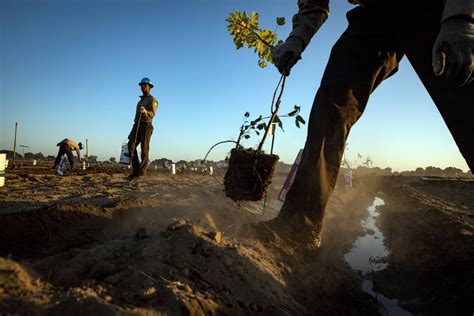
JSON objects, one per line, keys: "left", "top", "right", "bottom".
{"left": 0, "top": 167, "right": 474, "bottom": 315}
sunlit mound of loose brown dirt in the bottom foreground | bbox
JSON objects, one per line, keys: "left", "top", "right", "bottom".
{"left": 25, "top": 220, "right": 308, "bottom": 314}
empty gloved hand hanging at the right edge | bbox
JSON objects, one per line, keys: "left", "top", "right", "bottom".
{"left": 433, "top": 16, "right": 474, "bottom": 86}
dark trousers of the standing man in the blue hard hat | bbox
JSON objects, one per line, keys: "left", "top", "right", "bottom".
{"left": 128, "top": 122, "right": 153, "bottom": 174}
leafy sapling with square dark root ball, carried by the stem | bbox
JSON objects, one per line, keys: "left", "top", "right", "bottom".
{"left": 202, "top": 11, "right": 305, "bottom": 201}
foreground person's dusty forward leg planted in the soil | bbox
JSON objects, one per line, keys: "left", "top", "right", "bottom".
{"left": 276, "top": 8, "right": 402, "bottom": 245}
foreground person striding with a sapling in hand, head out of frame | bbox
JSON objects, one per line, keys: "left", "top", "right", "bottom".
{"left": 267, "top": 0, "right": 474, "bottom": 247}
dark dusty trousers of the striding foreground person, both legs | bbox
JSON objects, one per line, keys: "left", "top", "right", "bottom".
{"left": 278, "top": 0, "right": 474, "bottom": 243}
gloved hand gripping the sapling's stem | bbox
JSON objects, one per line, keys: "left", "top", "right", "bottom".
{"left": 272, "top": 36, "right": 303, "bottom": 76}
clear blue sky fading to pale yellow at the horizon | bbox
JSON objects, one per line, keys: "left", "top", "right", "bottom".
{"left": 0, "top": 0, "right": 468, "bottom": 170}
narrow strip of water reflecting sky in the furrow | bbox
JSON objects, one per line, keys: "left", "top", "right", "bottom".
{"left": 344, "top": 197, "right": 411, "bottom": 316}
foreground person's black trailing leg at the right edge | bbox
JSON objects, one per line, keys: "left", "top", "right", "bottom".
{"left": 402, "top": 1, "right": 474, "bottom": 171}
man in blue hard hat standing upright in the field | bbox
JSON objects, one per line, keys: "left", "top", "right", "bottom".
{"left": 128, "top": 78, "right": 158, "bottom": 178}
